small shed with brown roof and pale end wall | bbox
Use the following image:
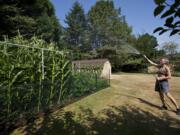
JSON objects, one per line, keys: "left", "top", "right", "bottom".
{"left": 72, "top": 59, "right": 111, "bottom": 79}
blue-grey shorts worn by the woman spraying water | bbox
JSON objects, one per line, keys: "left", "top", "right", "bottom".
{"left": 155, "top": 80, "right": 169, "bottom": 93}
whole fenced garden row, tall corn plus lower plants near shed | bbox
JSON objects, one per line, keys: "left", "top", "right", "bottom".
{"left": 0, "top": 36, "right": 108, "bottom": 133}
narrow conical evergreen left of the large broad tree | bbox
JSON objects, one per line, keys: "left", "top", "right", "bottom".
{"left": 65, "top": 2, "right": 87, "bottom": 50}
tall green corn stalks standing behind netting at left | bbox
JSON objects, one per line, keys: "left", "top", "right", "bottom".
{"left": 0, "top": 35, "right": 71, "bottom": 124}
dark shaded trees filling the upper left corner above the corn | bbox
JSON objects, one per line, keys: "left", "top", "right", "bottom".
{"left": 0, "top": 0, "right": 61, "bottom": 42}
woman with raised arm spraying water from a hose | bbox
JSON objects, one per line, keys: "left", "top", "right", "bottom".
{"left": 144, "top": 55, "right": 180, "bottom": 115}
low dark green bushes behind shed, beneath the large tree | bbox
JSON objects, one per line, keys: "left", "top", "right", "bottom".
{"left": 97, "top": 47, "right": 146, "bottom": 72}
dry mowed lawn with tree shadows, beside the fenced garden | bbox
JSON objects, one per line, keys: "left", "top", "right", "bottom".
{"left": 11, "top": 73, "right": 180, "bottom": 135}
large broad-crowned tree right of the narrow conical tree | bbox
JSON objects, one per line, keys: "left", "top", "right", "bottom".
{"left": 88, "top": 0, "right": 132, "bottom": 48}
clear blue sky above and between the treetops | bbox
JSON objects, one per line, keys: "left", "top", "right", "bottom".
{"left": 51, "top": 0, "right": 180, "bottom": 51}
